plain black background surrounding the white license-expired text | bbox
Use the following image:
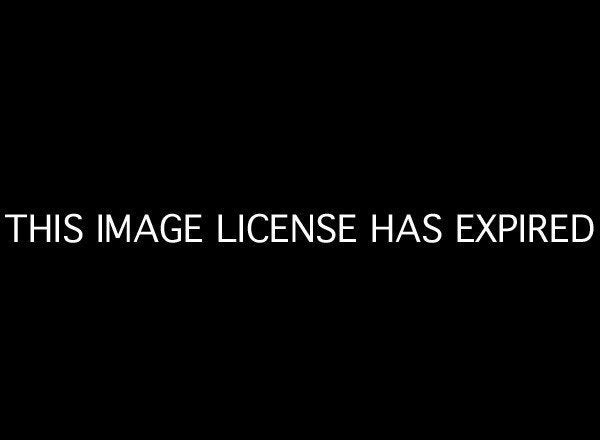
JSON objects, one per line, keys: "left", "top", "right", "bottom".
{"left": 1, "top": 5, "right": 598, "bottom": 433}
